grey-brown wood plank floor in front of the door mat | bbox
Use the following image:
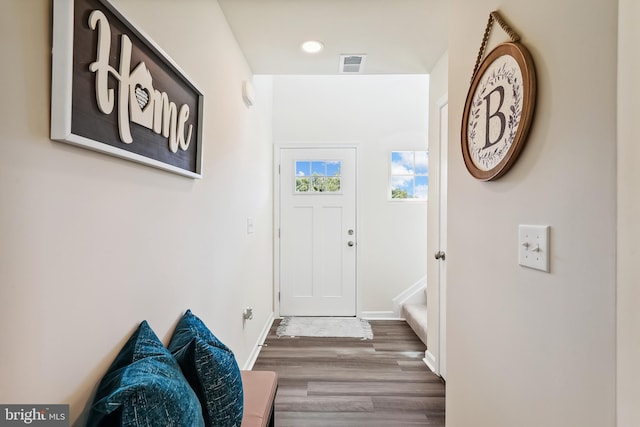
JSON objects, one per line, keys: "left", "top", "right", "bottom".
{"left": 253, "top": 320, "right": 445, "bottom": 427}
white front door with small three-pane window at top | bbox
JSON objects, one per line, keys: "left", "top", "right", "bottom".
{"left": 279, "top": 148, "right": 357, "bottom": 316}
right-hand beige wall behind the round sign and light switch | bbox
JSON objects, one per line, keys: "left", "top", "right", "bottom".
{"left": 447, "top": 0, "right": 616, "bottom": 427}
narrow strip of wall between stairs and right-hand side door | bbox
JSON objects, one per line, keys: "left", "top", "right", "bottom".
{"left": 427, "top": 53, "right": 449, "bottom": 374}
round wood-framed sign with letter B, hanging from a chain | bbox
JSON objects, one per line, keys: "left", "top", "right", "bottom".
{"left": 461, "top": 12, "right": 536, "bottom": 181}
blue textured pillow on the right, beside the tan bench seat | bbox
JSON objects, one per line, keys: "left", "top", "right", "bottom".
{"left": 169, "top": 310, "right": 244, "bottom": 427}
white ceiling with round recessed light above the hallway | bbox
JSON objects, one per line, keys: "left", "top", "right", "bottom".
{"left": 218, "top": 0, "right": 447, "bottom": 74}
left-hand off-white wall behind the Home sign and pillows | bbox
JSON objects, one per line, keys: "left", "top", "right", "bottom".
{"left": 0, "top": 0, "right": 273, "bottom": 424}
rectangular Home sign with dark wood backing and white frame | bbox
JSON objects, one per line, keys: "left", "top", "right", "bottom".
{"left": 51, "top": 0, "right": 204, "bottom": 178}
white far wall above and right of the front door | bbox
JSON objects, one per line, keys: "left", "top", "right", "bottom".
{"left": 273, "top": 75, "right": 429, "bottom": 315}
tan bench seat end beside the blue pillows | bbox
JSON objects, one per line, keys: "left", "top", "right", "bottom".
{"left": 240, "top": 371, "right": 278, "bottom": 427}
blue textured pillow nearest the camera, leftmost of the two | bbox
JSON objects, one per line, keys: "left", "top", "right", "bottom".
{"left": 87, "top": 320, "right": 204, "bottom": 427}
